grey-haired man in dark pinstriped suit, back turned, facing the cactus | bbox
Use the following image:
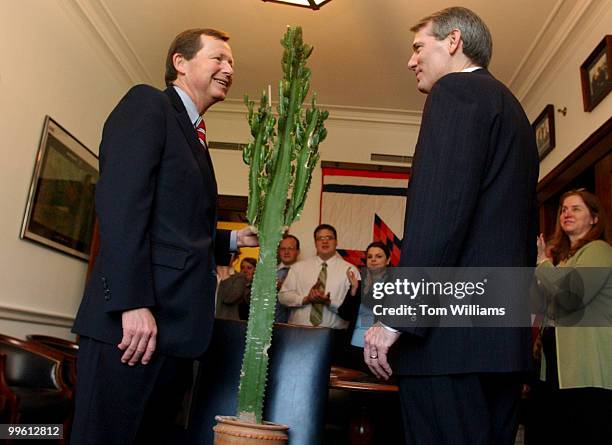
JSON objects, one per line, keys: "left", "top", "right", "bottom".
{"left": 364, "top": 7, "right": 538, "bottom": 445}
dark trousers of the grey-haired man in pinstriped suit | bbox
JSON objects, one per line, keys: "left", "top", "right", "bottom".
{"left": 399, "top": 373, "right": 522, "bottom": 445}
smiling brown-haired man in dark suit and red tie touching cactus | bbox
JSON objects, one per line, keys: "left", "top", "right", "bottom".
{"left": 72, "top": 29, "right": 257, "bottom": 444}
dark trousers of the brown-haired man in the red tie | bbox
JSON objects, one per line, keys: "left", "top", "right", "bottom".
{"left": 71, "top": 337, "right": 192, "bottom": 445}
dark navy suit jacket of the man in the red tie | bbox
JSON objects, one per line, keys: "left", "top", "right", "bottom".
{"left": 73, "top": 85, "right": 229, "bottom": 357}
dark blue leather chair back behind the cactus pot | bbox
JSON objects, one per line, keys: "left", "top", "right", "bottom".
{"left": 188, "top": 319, "right": 332, "bottom": 445}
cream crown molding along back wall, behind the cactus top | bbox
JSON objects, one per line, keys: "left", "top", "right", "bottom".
{"left": 208, "top": 99, "right": 422, "bottom": 127}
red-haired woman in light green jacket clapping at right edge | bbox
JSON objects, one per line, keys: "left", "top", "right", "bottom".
{"left": 536, "top": 189, "right": 612, "bottom": 444}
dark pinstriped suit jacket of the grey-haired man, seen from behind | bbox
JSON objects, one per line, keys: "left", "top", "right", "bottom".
{"left": 396, "top": 69, "right": 539, "bottom": 375}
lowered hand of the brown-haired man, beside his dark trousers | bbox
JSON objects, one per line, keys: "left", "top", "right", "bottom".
{"left": 117, "top": 307, "right": 157, "bottom": 366}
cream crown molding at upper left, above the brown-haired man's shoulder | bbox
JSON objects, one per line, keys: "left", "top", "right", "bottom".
{"left": 65, "top": 0, "right": 153, "bottom": 84}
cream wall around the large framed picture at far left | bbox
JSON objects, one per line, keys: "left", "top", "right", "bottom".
{"left": 0, "top": 0, "right": 134, "bottom": 337}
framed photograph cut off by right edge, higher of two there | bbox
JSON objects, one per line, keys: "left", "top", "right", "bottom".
{"left": 580, "top": 35, "right": 612, "bottom": 111}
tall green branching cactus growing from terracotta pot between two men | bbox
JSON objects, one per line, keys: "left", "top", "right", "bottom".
{"left": 238, "top": 26, "right": 329, "bottom": 423}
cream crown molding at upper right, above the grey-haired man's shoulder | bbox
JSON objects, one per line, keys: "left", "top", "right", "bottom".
{"left": 508, "top": 0, "right": 605, "bottom": 103}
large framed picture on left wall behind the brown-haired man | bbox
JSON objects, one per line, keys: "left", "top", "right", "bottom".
{"left": 21, "top": 116, "right": 99, "bottom": 260}
